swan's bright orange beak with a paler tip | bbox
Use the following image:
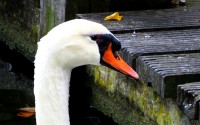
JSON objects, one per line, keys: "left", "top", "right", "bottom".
{"left": 102, "top": 43, "right": 139, "bottom": 79}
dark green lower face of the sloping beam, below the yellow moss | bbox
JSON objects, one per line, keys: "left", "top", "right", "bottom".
{"left": 92, "top": 84, "right": 153, "bottom": 125}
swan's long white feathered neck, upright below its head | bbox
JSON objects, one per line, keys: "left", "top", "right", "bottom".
{"left": 34, "top": 63, "right": 71, "bottom": 125}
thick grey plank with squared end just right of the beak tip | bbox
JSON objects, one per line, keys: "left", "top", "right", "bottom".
{"left": 136, "top": 53, "right": 200, "bottom": 98}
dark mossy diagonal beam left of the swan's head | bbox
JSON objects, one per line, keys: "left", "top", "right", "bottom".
{"left": 0, "top": 18, "right": 38, "bottom": 61}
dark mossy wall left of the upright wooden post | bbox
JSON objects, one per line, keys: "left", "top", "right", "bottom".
{"left": 0, "top": 0, "right": 40, "bottom": 61}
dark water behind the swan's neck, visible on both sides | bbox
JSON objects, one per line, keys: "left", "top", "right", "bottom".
{"left": 0, "top": 41, "right": 117, "bottom": 125}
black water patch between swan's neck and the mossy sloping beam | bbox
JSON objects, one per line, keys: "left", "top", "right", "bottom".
{"left": 69, "top": 66, "right": 117, "bottom": 125}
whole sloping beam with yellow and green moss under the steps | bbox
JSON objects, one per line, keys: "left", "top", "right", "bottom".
{"left": 87, "top": 66, "right": 195, "bottom": 125}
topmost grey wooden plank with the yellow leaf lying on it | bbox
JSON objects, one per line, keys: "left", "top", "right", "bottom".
{"left": 77, "top": 2, "right": 200, "bottom": 33}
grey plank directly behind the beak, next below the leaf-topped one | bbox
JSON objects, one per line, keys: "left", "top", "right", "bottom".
{"left": 115, "top": 29, "right": 200, "bottom": 68}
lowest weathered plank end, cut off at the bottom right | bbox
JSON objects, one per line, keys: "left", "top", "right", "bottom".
{"left": 177, "top": 82, "right": 200, "bottom": 120}
